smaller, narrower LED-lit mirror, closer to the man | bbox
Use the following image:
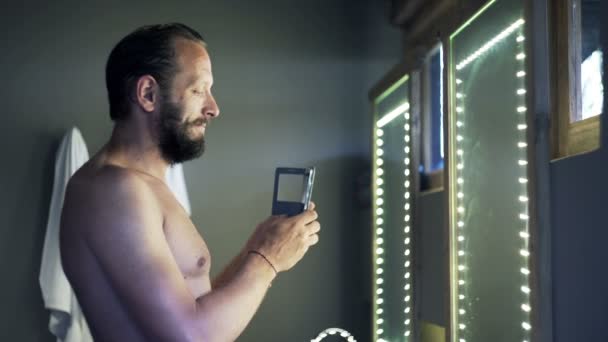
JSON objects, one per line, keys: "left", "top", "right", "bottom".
{"left": 372, "top": 75, "right": 414, "bottom": 341}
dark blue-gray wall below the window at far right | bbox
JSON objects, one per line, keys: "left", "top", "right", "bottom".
{"left": 551, "top": 146, "right": 608, "bottom": 342}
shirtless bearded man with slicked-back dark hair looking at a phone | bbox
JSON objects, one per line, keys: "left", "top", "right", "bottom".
{"left": 60, "top": 24, "right": 320, "bottom": 342}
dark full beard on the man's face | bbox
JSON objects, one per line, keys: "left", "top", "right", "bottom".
{"left": 157, "top": 101, "right": 206, "bottom": 165}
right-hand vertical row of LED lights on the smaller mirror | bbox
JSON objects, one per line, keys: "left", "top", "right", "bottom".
{"left": 403, "top": 106, "right": 414, "bottom": 341}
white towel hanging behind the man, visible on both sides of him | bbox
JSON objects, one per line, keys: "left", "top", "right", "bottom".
{"left": 39, "top": 127, "right": 191, "bottom": 342}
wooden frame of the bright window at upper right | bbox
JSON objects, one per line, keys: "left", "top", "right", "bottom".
{"left": 551, "top": 0, "right": 603, "bottom": 159}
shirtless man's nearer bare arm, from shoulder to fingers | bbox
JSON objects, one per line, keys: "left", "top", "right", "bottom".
{"left": 66, "top": 173, "right": 318, "bottom": 342}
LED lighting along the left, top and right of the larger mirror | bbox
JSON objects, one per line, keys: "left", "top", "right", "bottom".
{"left": 452, "top": 18, "right": 532, "bottom": 342}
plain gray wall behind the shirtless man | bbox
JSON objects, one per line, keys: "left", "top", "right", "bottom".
{"left": 0, "top": 0, "right": 400, "bottom": 341}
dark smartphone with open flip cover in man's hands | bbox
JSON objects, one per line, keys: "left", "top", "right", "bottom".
{"left": 272, "top": 167, "right": 315, "bottom": 216}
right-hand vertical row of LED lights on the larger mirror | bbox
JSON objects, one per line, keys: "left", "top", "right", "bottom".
{"left": 514, "top": 28, "right": 532, "bottom": 342}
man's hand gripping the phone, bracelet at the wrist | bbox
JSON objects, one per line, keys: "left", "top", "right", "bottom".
{"left": 246, "top": 202, "right": 321, "bottom": 272}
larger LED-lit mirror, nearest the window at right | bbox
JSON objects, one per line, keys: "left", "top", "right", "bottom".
{"left": 449, "top": 0, "right": 534, "bottom": 342}
